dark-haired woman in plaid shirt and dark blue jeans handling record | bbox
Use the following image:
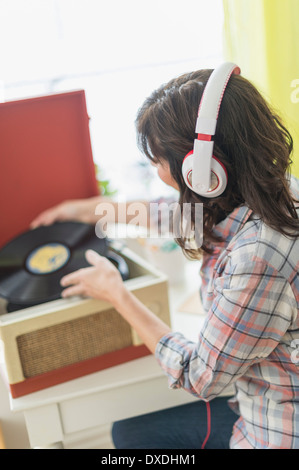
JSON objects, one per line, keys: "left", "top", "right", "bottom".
{"left": 31, "top": 63, "right": 299, "bottom": 449}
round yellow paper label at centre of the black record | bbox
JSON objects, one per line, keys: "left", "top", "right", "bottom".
{"left": 25, "top": 243, "right": 70, "bottom": 274}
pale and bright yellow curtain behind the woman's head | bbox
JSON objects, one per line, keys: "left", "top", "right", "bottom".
{"left": 223, "top": 0, "right": 299, "bottom": 177}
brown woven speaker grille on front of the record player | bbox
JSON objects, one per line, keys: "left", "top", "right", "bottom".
{"left": 17, "top": 309, "right": 132, "bottom": 378}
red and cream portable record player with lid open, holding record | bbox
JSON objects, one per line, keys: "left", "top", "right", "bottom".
{"left": 0, "top": 91, "right": 170, "bottom": 398}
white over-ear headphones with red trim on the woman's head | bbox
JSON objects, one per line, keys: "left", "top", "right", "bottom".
{"left": 182, "top": 62, "right": 241, "bottom": 198}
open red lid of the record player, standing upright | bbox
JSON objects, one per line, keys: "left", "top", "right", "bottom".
{"left": 0, "top": 90, "right": 99, "bottom": 247}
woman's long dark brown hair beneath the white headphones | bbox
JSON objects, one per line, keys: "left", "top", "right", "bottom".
{"left": 136, "top": 70, "right": 299, "bottom": 258}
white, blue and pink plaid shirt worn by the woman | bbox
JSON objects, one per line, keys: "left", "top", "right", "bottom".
{"left": 156, "top": 180, "right": 299, "bottom": 449}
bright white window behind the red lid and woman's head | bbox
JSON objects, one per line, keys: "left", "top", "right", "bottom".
{"left": 0, "top": 0, "right": 223, "bottom": 198}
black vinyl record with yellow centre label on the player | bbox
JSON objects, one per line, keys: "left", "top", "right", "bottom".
{"left": 0, "top": 222, "right": 129, "bottom": 311}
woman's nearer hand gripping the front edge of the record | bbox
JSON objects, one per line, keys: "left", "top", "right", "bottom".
{"left": 61, "top": 250, "right": 125, "bottom": 307}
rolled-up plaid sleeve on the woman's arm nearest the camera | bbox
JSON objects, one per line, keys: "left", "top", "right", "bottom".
{"left": 156, "top": 261, "right": 297, "bottom": 400}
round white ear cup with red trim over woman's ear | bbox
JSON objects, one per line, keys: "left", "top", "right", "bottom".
{"left": 182, "top": 151, "right": 227, "bottom": 198}
